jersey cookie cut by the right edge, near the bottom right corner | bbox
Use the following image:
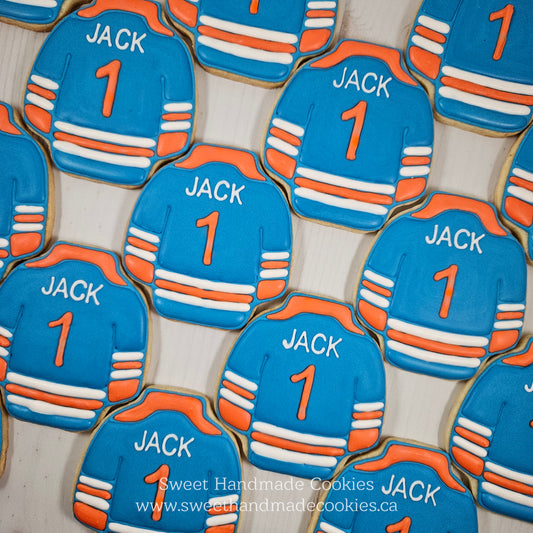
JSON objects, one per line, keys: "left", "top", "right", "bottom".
{"left": 449, "top": 337, "right": 533, "bottom": 522}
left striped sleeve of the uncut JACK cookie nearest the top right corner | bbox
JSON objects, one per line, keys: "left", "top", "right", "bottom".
{"left": 264, "top": 70, "right": 312, "bottom": 180}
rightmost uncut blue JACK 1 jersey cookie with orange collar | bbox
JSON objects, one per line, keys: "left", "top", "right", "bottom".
{"left": 356, "top": 192, "right": 527, "bottom": 379}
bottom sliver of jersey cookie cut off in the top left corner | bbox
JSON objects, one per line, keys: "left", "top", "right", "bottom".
{"left": 0, "top": 0, "right": 84, "bottom": 31}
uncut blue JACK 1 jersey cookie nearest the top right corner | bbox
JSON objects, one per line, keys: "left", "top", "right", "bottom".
{"left": 263, "top": 41, "right": 433, "bottom": 231}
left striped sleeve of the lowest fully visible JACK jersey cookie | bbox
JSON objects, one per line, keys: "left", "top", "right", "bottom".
{"left": 217, "top": 322, "right": 266, "bottom": 432}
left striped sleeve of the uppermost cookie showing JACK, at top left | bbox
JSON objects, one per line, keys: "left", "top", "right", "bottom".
{"left": 24, "top": 20, "right": 70, "bottom": 133}
